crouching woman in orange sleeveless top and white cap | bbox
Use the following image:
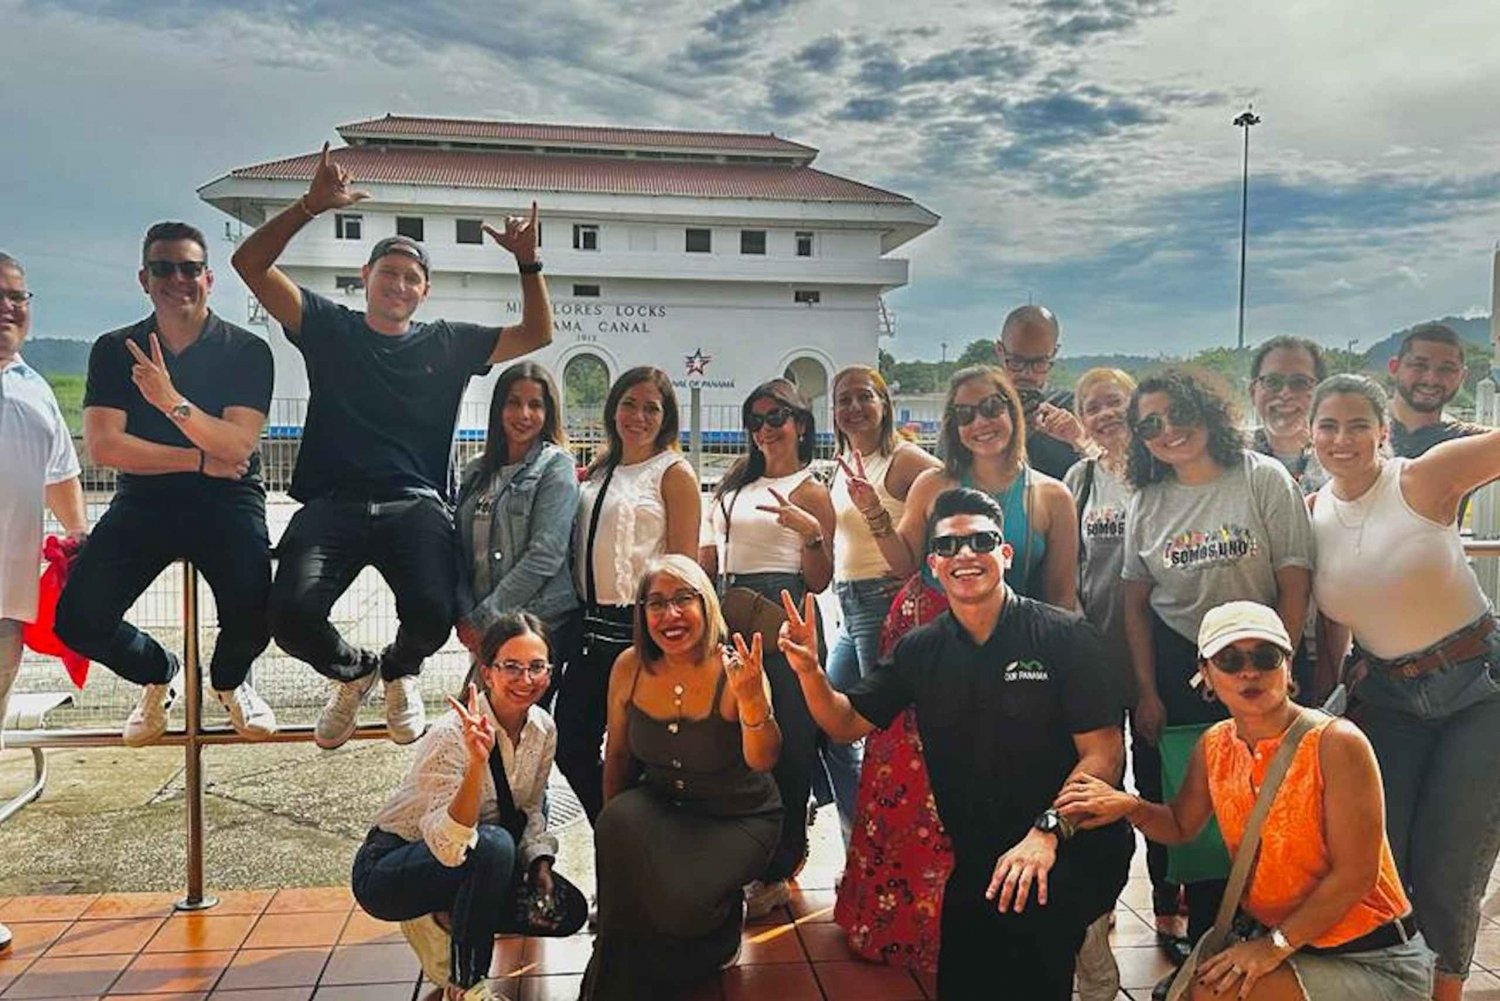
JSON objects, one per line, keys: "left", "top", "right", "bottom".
{"left": 1058, "top": 602, "right": 1433, "bottom": 1001}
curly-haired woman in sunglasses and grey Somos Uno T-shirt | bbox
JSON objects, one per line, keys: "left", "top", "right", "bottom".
{"left": 1122, "top": 368, "right": 1313, "bottom": 978}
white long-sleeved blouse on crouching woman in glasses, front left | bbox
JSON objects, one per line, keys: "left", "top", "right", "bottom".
{"left": 375, "top": 699, "right": 558, "bottom": 866}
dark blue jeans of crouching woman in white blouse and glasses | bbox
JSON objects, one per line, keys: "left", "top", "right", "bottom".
{"left": 353, "top": 824, "right": 516, "bottom": 987}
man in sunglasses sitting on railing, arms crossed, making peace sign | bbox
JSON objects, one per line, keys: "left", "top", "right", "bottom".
{"left": 57, "top": 222, "right": 276, "bottom": 747}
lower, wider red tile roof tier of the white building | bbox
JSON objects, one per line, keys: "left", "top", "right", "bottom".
{"left": 231, "top": 146, "right": 912, "bottom": 204}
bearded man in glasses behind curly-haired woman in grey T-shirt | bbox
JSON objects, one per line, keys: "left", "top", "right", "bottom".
{"left": 1250, "top": 336, "right": 1328, "bottom": 497}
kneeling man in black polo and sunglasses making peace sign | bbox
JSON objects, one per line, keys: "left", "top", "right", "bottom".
{"left": 780, "top": 488, "right": 1134, "bottom": 1001}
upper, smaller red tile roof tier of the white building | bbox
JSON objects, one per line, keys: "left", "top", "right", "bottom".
{"left": 338, "top": 114, "right": 818, "bottom": 156}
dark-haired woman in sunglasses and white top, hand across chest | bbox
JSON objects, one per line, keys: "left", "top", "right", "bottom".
{"left": 699, "top": 378, "right": 834, "bottom": 917}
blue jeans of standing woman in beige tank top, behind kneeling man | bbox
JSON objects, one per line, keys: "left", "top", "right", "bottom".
{"left": 815, "top": 576, "right": 902, "bottom": 848}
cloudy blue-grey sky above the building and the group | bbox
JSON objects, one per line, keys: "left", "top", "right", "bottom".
{"left": 0, "top": 0, "right": 1500, "bottom": 357}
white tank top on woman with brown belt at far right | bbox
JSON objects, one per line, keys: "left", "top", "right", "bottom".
{"left": 1313, "top": 459, "right": 1490, "bottom": 660}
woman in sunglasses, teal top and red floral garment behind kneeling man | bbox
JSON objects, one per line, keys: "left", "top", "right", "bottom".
{"left": 834, "top": 365, "right": 1079, "bottom": 971}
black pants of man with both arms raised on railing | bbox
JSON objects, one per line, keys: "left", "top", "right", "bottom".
{"left": 270, "top": 494, "right": 459, "bottom": 681}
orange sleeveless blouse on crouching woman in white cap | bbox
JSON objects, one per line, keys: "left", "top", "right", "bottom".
{"left": 1203, "top": 719, "right": 1412, "bottom": 948}
